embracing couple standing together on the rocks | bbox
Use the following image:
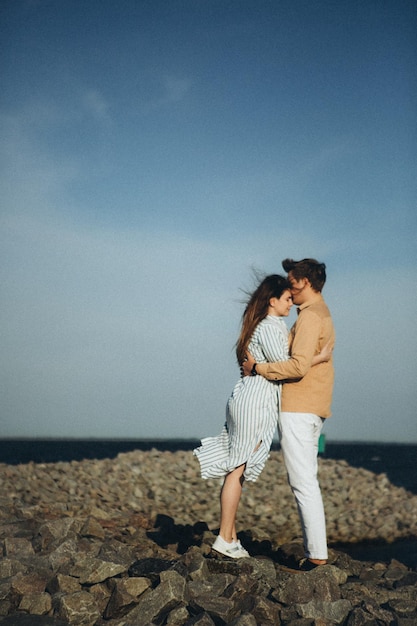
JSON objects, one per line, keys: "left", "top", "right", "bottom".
{"left": 194, "top": 259, "right": 335, "bottom": 570}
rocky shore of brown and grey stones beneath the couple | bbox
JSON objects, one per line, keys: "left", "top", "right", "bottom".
{"left": 0, "top": 449, "right": 417, "bottom": 626}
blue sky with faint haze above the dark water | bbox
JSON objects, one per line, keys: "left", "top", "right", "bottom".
{"left": 0, "top": 0, "right": 417, "bottom": 443}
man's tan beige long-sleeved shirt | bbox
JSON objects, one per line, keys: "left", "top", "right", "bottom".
{"left": 256, "top": 294, "right": 335, "bottom": 417}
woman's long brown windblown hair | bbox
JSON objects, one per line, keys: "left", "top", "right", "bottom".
{"left": 236, "top": 274, "right": 291, "bottom": 365}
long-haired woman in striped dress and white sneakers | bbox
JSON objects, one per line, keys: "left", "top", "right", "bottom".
{"left": 194, "top": 274, "right": 330, "bottom": 559}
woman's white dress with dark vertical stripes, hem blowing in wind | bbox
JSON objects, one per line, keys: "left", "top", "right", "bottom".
{"left": 194, "top": 315, "right": 288, "bottom": 481}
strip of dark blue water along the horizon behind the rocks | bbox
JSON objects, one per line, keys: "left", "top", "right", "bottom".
{"left": 0, "top": 439, "right": 417, "bottom": 494}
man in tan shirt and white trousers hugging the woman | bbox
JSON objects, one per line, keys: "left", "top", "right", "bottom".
{"left": 242, "top": 259, "right": 335, "bottom": 570}
